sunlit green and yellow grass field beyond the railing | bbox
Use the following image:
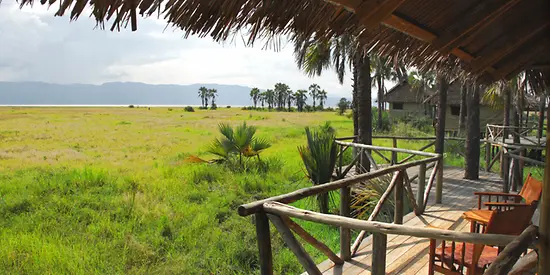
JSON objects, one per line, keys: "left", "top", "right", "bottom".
{"left": 0, "top": 108, "right": 544, "bottom": 274}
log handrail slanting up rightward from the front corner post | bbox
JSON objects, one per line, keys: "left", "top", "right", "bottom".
{"left": 238, "top": 154, "right": 442, "bottom": 216}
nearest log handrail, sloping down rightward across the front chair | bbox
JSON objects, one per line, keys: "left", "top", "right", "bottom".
{"left": 263, "top": 202, "right": 515, "bottom": 246}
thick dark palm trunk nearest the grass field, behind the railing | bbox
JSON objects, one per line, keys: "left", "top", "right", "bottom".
{"left": 357, "top": 55, "right": 372, "bottom": 171}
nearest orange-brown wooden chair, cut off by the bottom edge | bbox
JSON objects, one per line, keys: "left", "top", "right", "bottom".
{"left": 428, "top": 205, "right": 534, "bottom": 275}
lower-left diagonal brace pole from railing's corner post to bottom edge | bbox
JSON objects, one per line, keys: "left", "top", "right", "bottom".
{"left": 268, "top": 214, "right": 322, "bottom": 275}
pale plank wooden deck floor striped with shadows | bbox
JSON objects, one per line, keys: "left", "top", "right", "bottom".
{"left": 310, "top": 167, "right": 502, "bottom": 275}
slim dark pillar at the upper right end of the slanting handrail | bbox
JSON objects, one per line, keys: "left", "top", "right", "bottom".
{"left": 435, "top": 75, "right": 449, "bottom": 203}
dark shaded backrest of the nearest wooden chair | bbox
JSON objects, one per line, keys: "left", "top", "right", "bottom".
{"left": 485, "top": 204, "right": 537, "bottom": 235}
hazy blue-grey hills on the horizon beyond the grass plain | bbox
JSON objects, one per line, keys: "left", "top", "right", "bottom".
{"left": 0, "top": 82, "right": 339, "bottom": 106}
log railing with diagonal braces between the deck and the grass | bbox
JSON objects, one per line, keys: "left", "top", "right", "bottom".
{"left": 238, "top": 142, "right": 450, "bottom": 274}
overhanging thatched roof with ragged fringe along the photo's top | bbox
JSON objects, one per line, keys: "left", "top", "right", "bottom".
{"left": 12, "top": 0, "right": 550, "bottom": 86}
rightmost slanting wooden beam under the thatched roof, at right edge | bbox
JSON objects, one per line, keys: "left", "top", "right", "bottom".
{"left": 470, "top": 21, "right": 550, "bottom": 73}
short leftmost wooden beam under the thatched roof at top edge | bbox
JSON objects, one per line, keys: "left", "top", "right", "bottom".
{"left": 355, "top": 0, "right": 405, "bottom": 28}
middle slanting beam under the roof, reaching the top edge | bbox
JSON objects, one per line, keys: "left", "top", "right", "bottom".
{"left": 432, "top": 0, "right": 521, "bottom": 54}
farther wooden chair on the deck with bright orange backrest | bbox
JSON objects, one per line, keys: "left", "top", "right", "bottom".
{"left": 462, "top": 174, "right": 542, "bottom": 232}
